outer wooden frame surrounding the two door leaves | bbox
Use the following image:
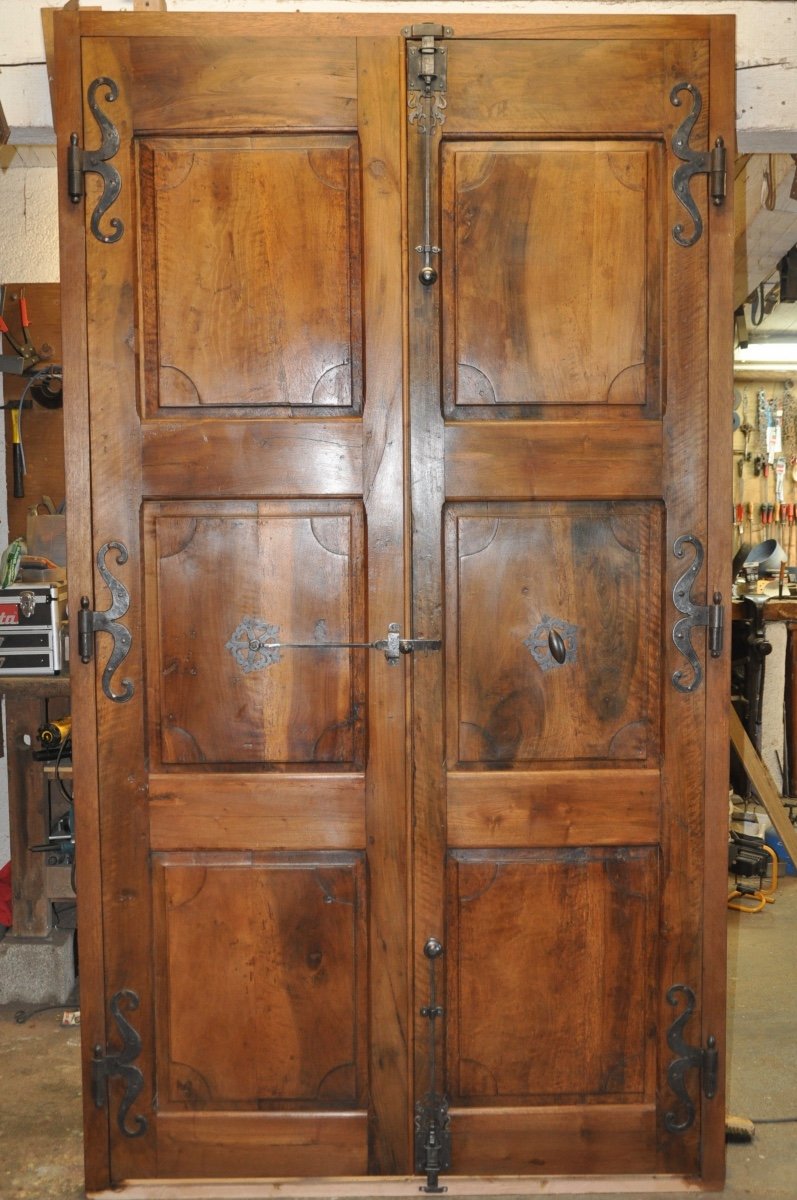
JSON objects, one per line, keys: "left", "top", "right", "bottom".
{"left": 54, "top": 10, "right": 735, "bottom": 1198}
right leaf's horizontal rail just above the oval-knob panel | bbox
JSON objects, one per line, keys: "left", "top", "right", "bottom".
{"left": 445, "top": 414, "right": 663, "bottom": 500}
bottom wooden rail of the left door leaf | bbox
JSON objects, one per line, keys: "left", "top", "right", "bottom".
{"left": 157, "top": 1112, "right": 367, "bottom": 1178}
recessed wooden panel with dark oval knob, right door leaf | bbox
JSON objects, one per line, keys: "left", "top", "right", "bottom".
{"left": 447, "top": 503, "right": 660, "bottom": 767}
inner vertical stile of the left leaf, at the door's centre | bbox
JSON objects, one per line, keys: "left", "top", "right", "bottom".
{"left": 358, "top": 38, "right": 411, "bottom": 1175}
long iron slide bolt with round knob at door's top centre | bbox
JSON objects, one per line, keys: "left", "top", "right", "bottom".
{"left": 402, "top": 24, "right": 454, "bottom": 288}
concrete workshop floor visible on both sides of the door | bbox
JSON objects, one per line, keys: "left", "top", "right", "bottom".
{"left": 0, "top": 877, "right": 797, "bottom": 1200}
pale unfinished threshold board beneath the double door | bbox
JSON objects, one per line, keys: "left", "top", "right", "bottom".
{"left": 86, "top": 1175, "right": 707, "bottom": 1200}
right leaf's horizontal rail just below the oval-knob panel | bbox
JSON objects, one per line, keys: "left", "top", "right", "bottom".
{"left": 448, "top": 770, "right": 661, "bottom": 847}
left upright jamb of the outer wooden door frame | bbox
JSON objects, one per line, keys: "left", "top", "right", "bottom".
{"left": 54, "top": 11, "right": 110, "bottom": 1190}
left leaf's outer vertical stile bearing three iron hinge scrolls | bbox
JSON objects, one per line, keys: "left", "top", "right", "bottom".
{"left": 83, "top": 38, "right": 156, "bottom": 1180}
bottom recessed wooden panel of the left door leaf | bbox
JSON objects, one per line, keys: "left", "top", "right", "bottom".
{"left": 156, "top": 854, "right": 367, "bottom": 1112}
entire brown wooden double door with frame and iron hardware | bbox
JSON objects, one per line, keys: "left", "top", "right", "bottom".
{"left": 56, "top": 11, "right": 732, "bottom": 1195}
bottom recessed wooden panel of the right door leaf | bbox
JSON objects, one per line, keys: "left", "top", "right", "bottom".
{"left": 449, "top": 847, "right": 657, "bottom": 1099}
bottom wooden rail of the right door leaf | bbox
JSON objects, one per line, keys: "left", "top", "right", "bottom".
{"left": 451, "top": 1104, "right": 657, "bottom": 1182}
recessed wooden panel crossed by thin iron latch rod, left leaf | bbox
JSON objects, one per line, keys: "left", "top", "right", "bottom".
{"left": 145, "top": 502, "right": 365, "bottom": 770}
